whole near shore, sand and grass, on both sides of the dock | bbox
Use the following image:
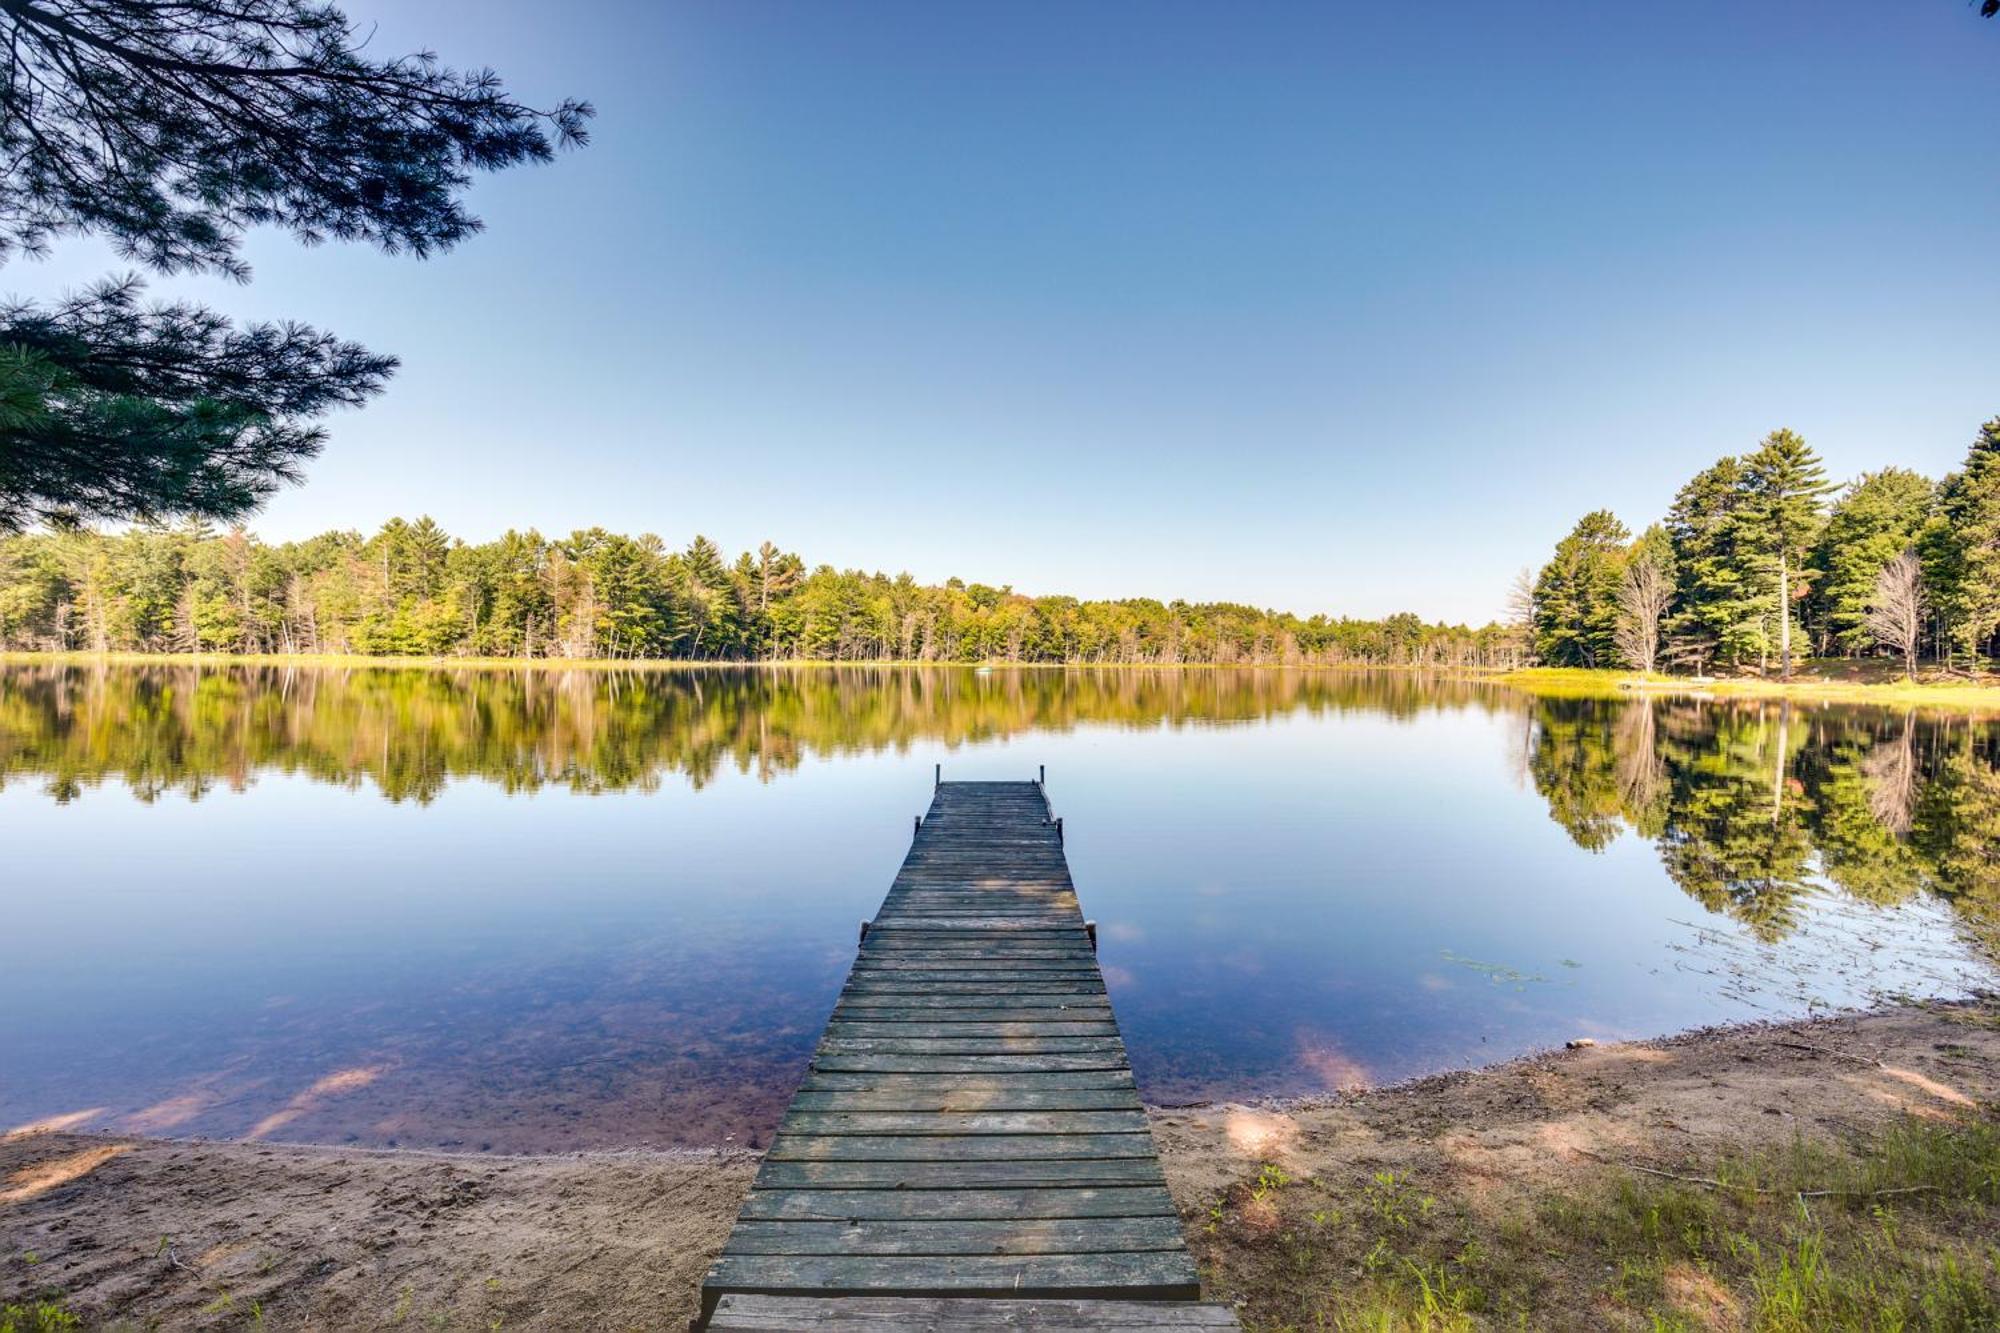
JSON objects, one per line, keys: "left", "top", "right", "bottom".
{"left": 0, "top": 997, "right": 2000, "bottom": 1331}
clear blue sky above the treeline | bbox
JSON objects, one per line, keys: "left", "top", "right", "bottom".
{"left": 0, "top": 0, "right": 2000, "bottom": 618}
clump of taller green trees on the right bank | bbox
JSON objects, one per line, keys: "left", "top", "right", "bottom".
{"left": 1514, "top": 418, "right": 2000, "bottom": 675}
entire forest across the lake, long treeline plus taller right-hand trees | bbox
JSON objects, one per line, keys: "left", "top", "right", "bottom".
{"left": 0, "top": 418, "right": 2000, "bottom": 677}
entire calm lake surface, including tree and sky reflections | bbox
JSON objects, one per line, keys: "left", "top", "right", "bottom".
{"left": 0, "top": 667, "right": 2000, "bottom": 1151}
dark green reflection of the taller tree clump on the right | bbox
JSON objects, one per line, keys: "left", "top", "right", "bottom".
{"left": 1528, "top": 699, "right": 2000, "bottom": 949}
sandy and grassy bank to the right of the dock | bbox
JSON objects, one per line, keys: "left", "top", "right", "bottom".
{"left": 1152, "top": 997, "right": 2000, "bottom": 1333}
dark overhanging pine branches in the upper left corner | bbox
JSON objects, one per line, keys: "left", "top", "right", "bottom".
{"left": 0, "top": 0, "right": 592, "bottom": 528}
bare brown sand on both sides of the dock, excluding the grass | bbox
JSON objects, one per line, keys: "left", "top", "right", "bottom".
{"left": 0, "top": 1001, "right": 2000, "bottom": 1329}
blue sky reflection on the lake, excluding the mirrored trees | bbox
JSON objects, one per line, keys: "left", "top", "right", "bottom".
{"left": 0, "top": 668, "right": 1992, "bottom": 1151}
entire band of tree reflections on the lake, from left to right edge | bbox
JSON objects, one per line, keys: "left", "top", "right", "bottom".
{"left": 0, "top": 664, "right": 2000, "bottom": 947}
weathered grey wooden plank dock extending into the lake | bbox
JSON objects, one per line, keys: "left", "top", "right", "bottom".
{"left": 702, "top": 781, "right": 1236, "bottom": 1333}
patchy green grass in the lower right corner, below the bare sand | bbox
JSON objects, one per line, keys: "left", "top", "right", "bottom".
{"left": 1196, "top": 1109, "right": 2000, "bottom": 1333}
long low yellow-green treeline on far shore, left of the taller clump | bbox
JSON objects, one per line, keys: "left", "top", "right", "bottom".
{"left": 0, "top": 518, "right": 1526, "bottom": 667}
